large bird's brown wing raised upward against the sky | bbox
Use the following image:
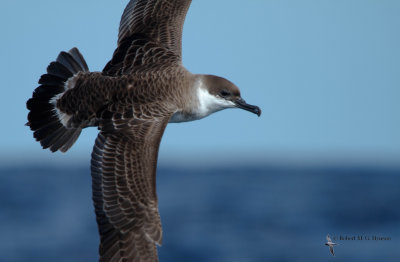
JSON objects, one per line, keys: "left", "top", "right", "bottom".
{"left": 103, "top": 0, "right": 191, "bottom": 76}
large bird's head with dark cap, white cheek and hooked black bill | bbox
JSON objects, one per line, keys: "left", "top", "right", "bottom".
{"left": 197, "top": 75, "right": 261, "bottom": 117}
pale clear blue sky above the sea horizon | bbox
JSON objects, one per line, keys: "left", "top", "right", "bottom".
{"left": 0, "top": 0, "right": 400, "bottom": 166}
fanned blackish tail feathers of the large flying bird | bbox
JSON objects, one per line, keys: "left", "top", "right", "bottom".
{"left": 26, "top": 48, "right": 89, "bottom": 152}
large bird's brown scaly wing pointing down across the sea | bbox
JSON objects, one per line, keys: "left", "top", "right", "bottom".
{"left": 91, "top": 117, "right": 169, "bottom": 262}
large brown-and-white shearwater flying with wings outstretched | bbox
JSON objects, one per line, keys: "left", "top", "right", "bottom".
{"left": 27, "top": 0, "right": 261, "bottom": 262}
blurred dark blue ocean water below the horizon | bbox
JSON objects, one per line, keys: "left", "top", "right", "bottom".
{"left": 0, "top": 165, "right": 400, "bottom": 262}
